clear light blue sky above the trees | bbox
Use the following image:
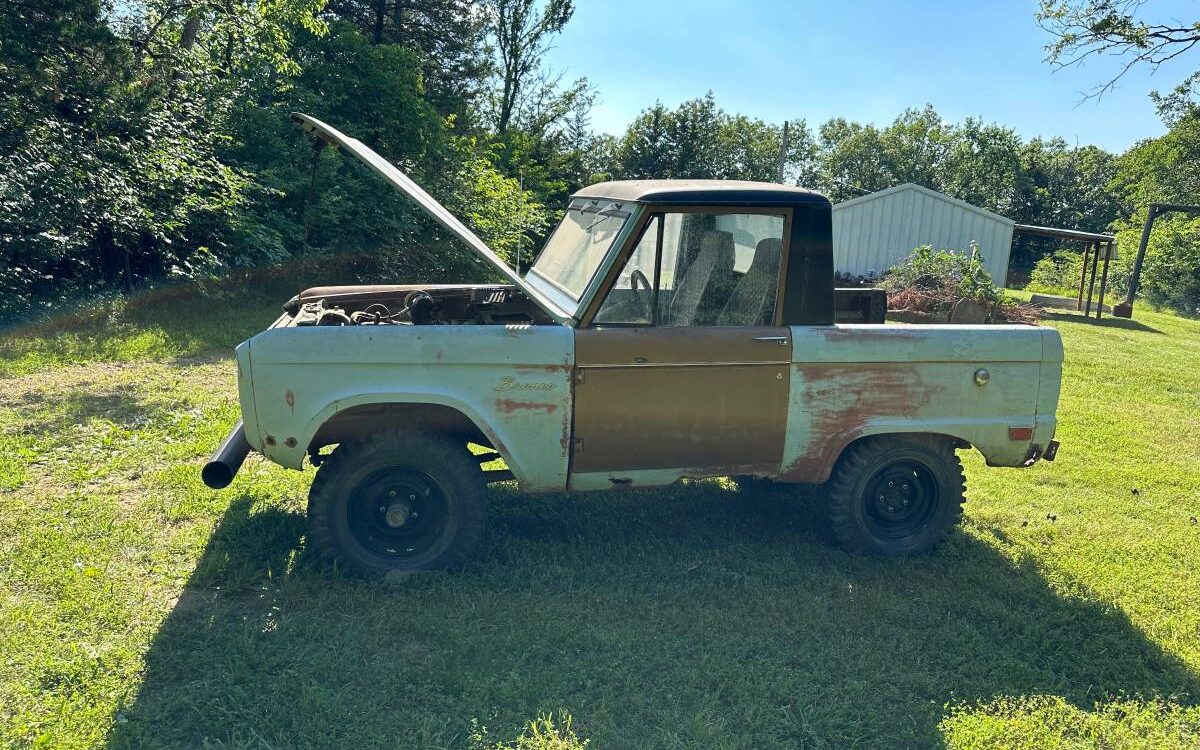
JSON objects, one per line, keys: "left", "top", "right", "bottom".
{"left": 548, "top": 0, "right": 1200, "bottom": 150}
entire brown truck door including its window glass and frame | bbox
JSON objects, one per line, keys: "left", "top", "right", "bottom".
{"left": 571, "top": 209, "right": 792, "bottom": 475}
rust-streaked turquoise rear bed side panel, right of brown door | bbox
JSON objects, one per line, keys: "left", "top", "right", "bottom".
{"left": 782, "top": 325, "right": 1062, "bottom": 482}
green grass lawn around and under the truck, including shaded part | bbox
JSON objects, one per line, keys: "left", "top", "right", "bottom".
{"left": 0, "top": 282, "right": 1200, "bottom": 750}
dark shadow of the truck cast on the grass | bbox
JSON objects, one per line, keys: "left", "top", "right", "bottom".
{"left": 108, "top": 481, "right": 1198, "bottom": 748}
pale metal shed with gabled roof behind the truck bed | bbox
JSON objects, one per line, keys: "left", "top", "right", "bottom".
{"left": 833, "top": 182, "right": 1015, "bottom": 286}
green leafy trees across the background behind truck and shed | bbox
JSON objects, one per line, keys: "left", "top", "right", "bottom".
{"left": 0, "top": 0, "right": 1200, "bottom": 319}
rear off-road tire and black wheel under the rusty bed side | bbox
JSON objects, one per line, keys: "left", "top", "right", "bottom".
{"left": 824, "top": 436, "right": 966, "bottom": 556}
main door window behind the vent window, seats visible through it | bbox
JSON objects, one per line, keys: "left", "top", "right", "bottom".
{"left": 656, "top": 214, "right": 784, "bottom": 326}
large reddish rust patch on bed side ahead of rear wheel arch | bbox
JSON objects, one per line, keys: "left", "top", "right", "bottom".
{"left": 781, "top": 365, "right": 941, "bottom": 482}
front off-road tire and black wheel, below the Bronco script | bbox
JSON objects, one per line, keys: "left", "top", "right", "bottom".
{"left": 308, "top": 431, "right": 487, "bottom": 577}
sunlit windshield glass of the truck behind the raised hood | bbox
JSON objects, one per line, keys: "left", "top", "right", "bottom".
{"left": 529, "top": 199, "right": 629, "bottom": 301}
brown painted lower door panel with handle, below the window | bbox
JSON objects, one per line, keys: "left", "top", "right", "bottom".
{"left": 571, "top": 326, "right": 791, "bottom": 476}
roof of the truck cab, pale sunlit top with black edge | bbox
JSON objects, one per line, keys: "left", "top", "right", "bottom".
{"left": 574, "top": 180, "right": 829, "bottom": 206}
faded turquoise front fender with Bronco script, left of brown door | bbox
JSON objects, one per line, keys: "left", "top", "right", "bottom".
{"left": 239, "top": 325, "right": 575, "bottom": 491}
